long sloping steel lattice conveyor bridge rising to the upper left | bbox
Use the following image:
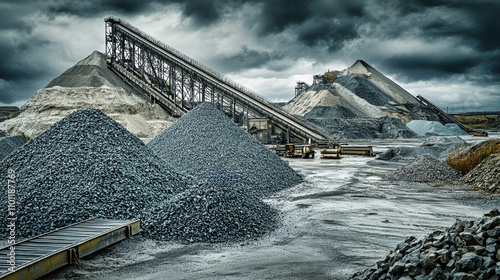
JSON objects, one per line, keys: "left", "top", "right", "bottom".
{"left": 104, "top": 17, "right": 329, "bottom": 142}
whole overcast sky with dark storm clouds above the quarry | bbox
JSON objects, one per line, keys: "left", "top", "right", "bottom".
{"left": 0, "top": 0, "right": 500, "bottom": 112}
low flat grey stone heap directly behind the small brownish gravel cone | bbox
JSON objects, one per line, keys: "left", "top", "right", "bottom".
{"left": 377, "top": 136, "right": 469, "bottom": 162}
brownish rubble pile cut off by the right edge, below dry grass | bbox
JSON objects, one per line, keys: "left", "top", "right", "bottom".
{"left": 458, "top": 153, "right": 500, "bottom": 194}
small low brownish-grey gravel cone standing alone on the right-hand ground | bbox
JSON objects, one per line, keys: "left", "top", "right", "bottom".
{"left": 387, "top": 154, "right": 461, "bottom": 182}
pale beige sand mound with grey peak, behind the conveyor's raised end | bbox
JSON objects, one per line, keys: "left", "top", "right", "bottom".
{"left": 0, "top": 51, "right": 175, "bottom": 138}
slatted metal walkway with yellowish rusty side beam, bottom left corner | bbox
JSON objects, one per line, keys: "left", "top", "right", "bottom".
{"left": 0, "top": 219, "right": 140, "bottom": 280}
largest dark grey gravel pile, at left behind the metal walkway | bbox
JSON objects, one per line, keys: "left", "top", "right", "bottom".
{"left": 0, "top": 109, "right": 191, "bottom": 240}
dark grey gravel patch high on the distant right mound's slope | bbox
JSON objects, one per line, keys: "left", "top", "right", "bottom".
{"left": 335, "top": 75, "right": 396, "bottom": 106}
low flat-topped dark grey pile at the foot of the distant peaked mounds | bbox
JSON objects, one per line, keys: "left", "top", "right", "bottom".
{"left": 305, "top": 117, "right": 417, "bottom": 140}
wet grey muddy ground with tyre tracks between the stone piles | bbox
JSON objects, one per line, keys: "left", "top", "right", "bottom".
{"left": 44, "top": 137, "right": 500, "bottom": 280}
